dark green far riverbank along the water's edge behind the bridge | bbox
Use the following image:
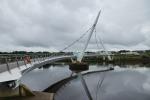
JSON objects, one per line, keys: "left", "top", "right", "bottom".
{"left": 53, "top": 54, "right": 150, "bottom": 67}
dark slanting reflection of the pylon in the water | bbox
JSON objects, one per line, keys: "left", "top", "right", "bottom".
{"left": 77, "top": 72, "right": 93, "bottom": 100}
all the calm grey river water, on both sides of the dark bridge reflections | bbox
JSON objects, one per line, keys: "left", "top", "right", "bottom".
{"left": 21, "top": 65, "right": 150, "bottom": 100}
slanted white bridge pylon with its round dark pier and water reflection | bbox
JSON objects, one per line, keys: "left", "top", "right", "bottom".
{"left": 69, "top": 10, "right": 101, "bottom": 100}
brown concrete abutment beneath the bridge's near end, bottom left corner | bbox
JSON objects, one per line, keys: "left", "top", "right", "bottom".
{"left": 0, "top": 84, "right": 54, "bottom": 100}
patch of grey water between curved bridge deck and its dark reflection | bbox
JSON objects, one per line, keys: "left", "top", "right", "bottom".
{"left": 21, "top": 66, "right": 71, "bottom": 91}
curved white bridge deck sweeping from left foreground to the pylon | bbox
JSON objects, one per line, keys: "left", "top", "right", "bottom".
{"left": 0, "top": 55, "right": 74, "bottom": 82}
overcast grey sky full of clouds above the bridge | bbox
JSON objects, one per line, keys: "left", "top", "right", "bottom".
{"left": 0, "top": 0, "right": 150, "bottom": 51}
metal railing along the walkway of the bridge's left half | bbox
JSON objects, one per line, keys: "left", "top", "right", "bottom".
{"left": 0, "top": 53, "right": 70, "bottom": 73}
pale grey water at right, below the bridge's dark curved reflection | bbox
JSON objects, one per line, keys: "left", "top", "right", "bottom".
{"left": 55, "top": 66, "right": 150, "bottom": 100}
